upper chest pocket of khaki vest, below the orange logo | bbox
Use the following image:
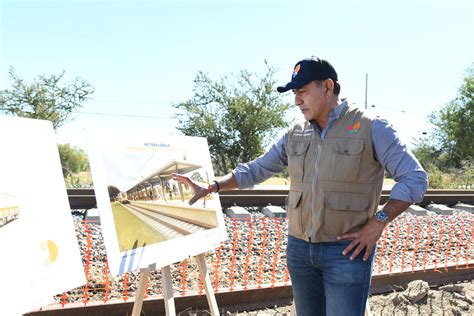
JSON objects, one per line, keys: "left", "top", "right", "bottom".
{"left": 330, "top": 139, "right": 364, "bottom": 182}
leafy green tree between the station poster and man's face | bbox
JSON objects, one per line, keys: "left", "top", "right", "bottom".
{"left": 173, "top": 62, "right": 290, "bottom": 174}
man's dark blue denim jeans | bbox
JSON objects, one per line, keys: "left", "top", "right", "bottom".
{"left": 286, "top": 236, "right": 375, "bottom": 316}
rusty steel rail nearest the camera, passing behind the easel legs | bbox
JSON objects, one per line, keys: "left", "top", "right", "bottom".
{"left": 28, "top": 262, "right": 474, "bottom": 316}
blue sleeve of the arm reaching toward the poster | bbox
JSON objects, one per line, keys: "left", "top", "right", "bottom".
{"left": 232, "top": 135, "right": 288, "bottom": 189}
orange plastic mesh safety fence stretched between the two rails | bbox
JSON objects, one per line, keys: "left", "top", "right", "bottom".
{"left": 65, "top": 215, "right": 474, "bottom": 307}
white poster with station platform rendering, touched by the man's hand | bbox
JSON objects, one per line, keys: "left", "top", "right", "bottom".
{"left": 87, "top": 130, "right": 226, "bottom": 275}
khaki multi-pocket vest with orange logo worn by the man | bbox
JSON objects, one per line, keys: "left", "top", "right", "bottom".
{"left": 285, "top": 107, "right": 384, "bottom": 242}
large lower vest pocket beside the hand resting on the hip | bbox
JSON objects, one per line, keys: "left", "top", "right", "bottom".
{"left": 324, "top": 192, "right": 369, "bottom": 235}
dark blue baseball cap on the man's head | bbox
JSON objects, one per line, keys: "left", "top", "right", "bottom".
{"left": 277, "top": 58, "right": 337, "bottom": 92}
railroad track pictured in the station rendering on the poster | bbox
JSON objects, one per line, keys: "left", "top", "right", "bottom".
{"left": 122, "top": 202, "right": 206, "bottom": 239}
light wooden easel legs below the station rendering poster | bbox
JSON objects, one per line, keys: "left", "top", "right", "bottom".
{"left": 132, "top": 254, "right": 219, "bottom": 316}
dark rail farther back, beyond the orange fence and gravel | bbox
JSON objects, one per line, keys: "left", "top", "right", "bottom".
{"left": 67, "top": 189, "right": 474, "bottom": 210}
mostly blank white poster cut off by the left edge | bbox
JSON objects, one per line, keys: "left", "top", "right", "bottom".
{"left": 0, "top": 116, "right": 86, "bottom": 315}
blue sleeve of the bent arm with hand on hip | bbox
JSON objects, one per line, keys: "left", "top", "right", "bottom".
{"left": 372, "top": 119, "right": 428, "bottom": 203}
